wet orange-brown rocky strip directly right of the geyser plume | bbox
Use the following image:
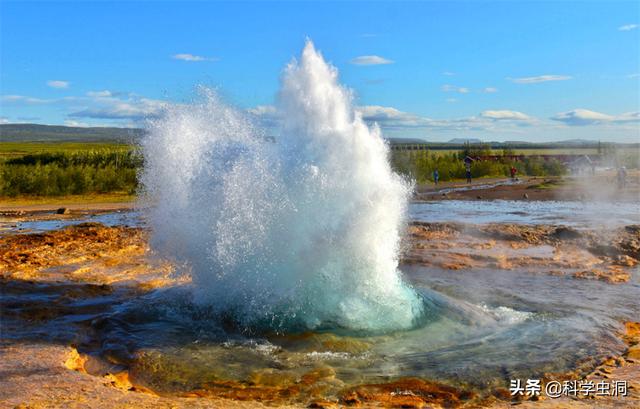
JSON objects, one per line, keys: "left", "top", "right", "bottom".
{"left": 403, "top": 222, "right": 640, "bottom": 283}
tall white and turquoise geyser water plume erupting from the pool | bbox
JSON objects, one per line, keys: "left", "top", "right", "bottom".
{"left": 142, "top": 41, "right": 423, "bottom": 331}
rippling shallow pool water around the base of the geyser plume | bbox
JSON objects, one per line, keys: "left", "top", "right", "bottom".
{"left": 74, "top": 267, "right": 640, "bottom": 390}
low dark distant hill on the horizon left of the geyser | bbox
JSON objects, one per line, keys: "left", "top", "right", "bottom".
{"left": 0, "top": 124, "right": 144, "bottom": 143}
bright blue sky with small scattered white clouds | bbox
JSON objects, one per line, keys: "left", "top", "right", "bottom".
{"left": 0, "top": 1, "right": 640, "bottom": 142}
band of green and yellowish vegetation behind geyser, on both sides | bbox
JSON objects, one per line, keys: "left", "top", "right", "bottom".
{"left": 0, "top": 135, "right": 640, "bottom": 197}
